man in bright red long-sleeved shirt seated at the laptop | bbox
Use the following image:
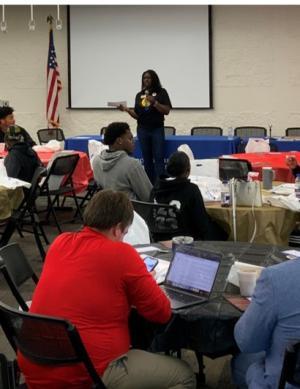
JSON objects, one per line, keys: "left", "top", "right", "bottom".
{"left": 18, "top": 190, "right": 196, "bottom": 389}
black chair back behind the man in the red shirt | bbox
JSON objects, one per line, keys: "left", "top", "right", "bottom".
{"left": 0, "top": 302, "right": 105, "bottom": 389}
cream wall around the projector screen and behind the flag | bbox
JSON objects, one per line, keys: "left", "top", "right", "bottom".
{"left": 0, "top": 6, "right": 300, "bottom": 141}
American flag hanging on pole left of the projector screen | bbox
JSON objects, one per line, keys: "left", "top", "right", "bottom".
{"left": 47, "top": 26, "right": 62, "bottom": 123}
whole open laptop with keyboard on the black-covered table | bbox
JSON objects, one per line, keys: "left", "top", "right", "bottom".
{"left": 161, "top": 246, "right": 221, "bottom": 310}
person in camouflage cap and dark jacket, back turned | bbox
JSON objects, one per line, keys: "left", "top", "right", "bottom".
{"left": 4, "top": 126, "right": 42, "bottom": 182}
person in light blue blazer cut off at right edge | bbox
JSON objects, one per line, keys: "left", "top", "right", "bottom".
{"left": 232, "top": 259, "right": 300, "bottom": 389}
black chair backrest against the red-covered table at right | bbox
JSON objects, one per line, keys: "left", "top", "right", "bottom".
{"left": 219, "top": 158, "right": 252, "bottom": 181}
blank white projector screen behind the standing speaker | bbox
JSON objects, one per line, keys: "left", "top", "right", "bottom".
{"left": 69, "top": 5, "right": 212, "bottom": 108}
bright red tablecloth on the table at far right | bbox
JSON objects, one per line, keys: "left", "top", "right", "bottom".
{"left": 232, "top": 151, "right": 300, "bottom": 182}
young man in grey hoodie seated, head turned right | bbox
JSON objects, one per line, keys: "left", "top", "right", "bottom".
{"left": 92, "top": 122, "right": 152, "bottom": 201}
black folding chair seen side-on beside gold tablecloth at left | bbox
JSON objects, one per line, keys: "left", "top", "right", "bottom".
{"left": 0, "top": 167, "right": 49, "bottom": 259}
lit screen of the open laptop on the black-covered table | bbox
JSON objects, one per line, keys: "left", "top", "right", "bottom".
{"left": 166, "top": 251, "right": 220, "bottom": 293}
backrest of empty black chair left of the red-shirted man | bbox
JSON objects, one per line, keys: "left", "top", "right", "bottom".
{"left": 0, "top": 243, "right": 38, "bottom": 311}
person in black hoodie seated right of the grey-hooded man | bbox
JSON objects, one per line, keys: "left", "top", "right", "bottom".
{"left": 151, "top": 151, "right": 227, "bottom": 240}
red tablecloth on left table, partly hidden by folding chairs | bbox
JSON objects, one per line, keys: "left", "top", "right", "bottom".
{"left": 0, "top": 151, "right": 93, "bottom": 193}
